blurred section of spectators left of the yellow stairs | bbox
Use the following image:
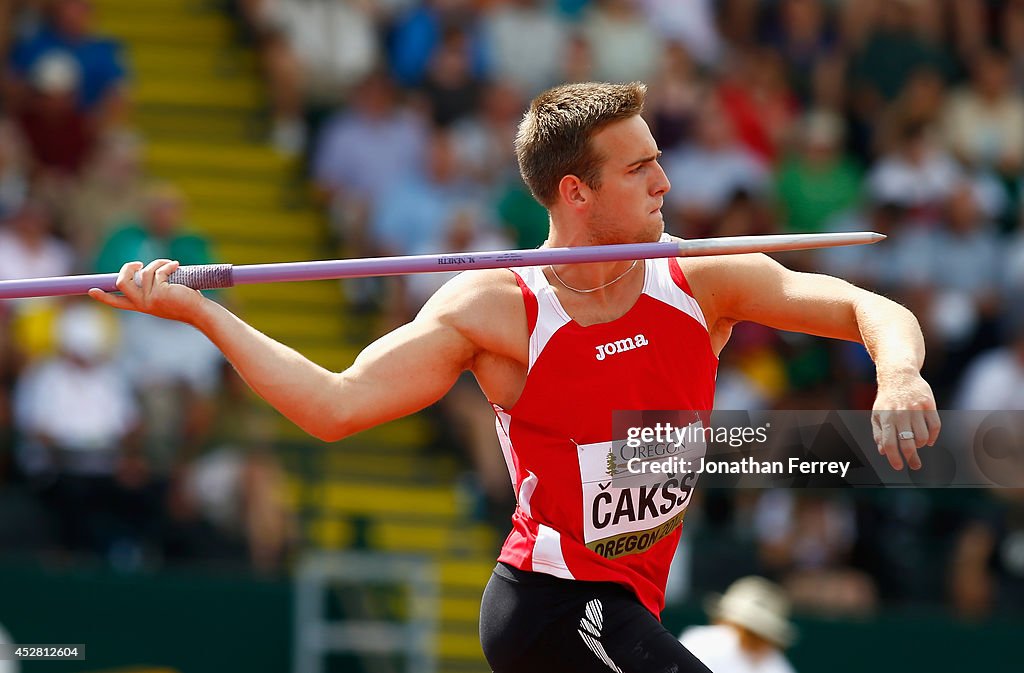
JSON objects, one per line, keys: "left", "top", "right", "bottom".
{"left": 0, "top": 0, "right": 292, "bottom": 572}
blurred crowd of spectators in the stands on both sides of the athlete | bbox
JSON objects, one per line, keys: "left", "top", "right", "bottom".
{"left": 0, "top": 0, "right": 1024, "bottom": 617}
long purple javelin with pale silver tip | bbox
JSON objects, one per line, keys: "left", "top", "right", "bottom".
{"left": 0, "top": 232, "right": 886, "bottom": 299}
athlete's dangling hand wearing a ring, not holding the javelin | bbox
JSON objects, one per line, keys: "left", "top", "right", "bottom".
{"left": 871, "top": 372, "right": 942, "bottom": 470}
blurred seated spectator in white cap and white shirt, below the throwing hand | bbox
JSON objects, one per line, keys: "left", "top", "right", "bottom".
{"left": 13, "top": 302, "right": 149, "bottom": 560}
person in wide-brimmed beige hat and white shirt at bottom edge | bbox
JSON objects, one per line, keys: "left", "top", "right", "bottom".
{"left": 679, "top": 577, "right": 797, "bottom": 673}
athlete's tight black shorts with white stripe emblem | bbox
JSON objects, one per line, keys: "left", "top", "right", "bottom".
{"left": 480, "top": 563, "right": 710, "bottom": 673}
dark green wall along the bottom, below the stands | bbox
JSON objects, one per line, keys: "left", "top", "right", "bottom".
{"left": 0, "top": 564, "right": 1024, "bottom": 673}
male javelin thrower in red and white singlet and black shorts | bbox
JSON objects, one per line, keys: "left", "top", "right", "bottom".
{"left": 90, "top": 83, "right": 939, "bottom": 673}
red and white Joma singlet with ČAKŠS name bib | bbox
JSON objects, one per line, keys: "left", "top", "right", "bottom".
{"left": 493, "top": 251, "right": 718, "bottom": 616}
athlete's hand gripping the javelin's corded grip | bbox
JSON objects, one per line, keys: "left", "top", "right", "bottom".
{"left": 89, "top": 259, "right": 203, "bottom": 324}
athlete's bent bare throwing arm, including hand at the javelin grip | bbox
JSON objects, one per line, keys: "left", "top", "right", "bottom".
{"left": 90, "top": 260, "right": 505, "bottom": 441}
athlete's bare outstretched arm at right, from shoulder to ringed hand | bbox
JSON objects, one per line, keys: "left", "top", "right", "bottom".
{"left": 686, "top": 255, "right": 940, "bottom": 469}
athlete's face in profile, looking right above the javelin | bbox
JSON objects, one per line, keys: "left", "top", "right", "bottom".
{"left": 588, "top": 116, "right": 671, "bottom": 244}
